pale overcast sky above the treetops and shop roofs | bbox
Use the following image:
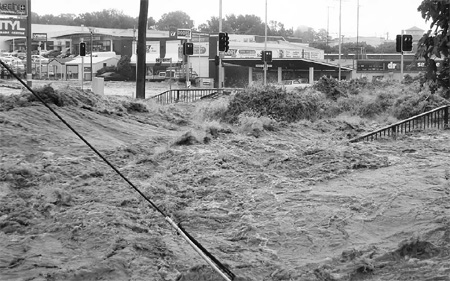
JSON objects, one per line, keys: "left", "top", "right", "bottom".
{"left": 31, "top": 0, "right": 429, "bottom": 39}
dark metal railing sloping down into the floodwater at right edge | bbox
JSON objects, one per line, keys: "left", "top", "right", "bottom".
{"left": 350, "top": 105, "right": 450, "bottom": 142}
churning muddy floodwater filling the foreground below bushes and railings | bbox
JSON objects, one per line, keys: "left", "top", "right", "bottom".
{"left": 0, "top": 83, "right": 450, "bottom": 281}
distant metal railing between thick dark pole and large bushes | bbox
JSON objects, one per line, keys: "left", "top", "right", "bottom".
{"left": 152, "top": 88, "right": 223, "bottom": 104}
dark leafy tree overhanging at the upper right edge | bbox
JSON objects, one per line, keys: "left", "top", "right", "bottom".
{"left": 416, "top": 0, "right": 450, "bottom": 95}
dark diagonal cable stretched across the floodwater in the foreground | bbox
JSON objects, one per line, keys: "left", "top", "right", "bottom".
{"left": 0, "top": 60, "right": 236, "bottom": 281}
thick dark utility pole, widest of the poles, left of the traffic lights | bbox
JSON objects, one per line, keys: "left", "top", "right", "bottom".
{"left": 136, "top": 0, "right": 148, "bottom": 99}
